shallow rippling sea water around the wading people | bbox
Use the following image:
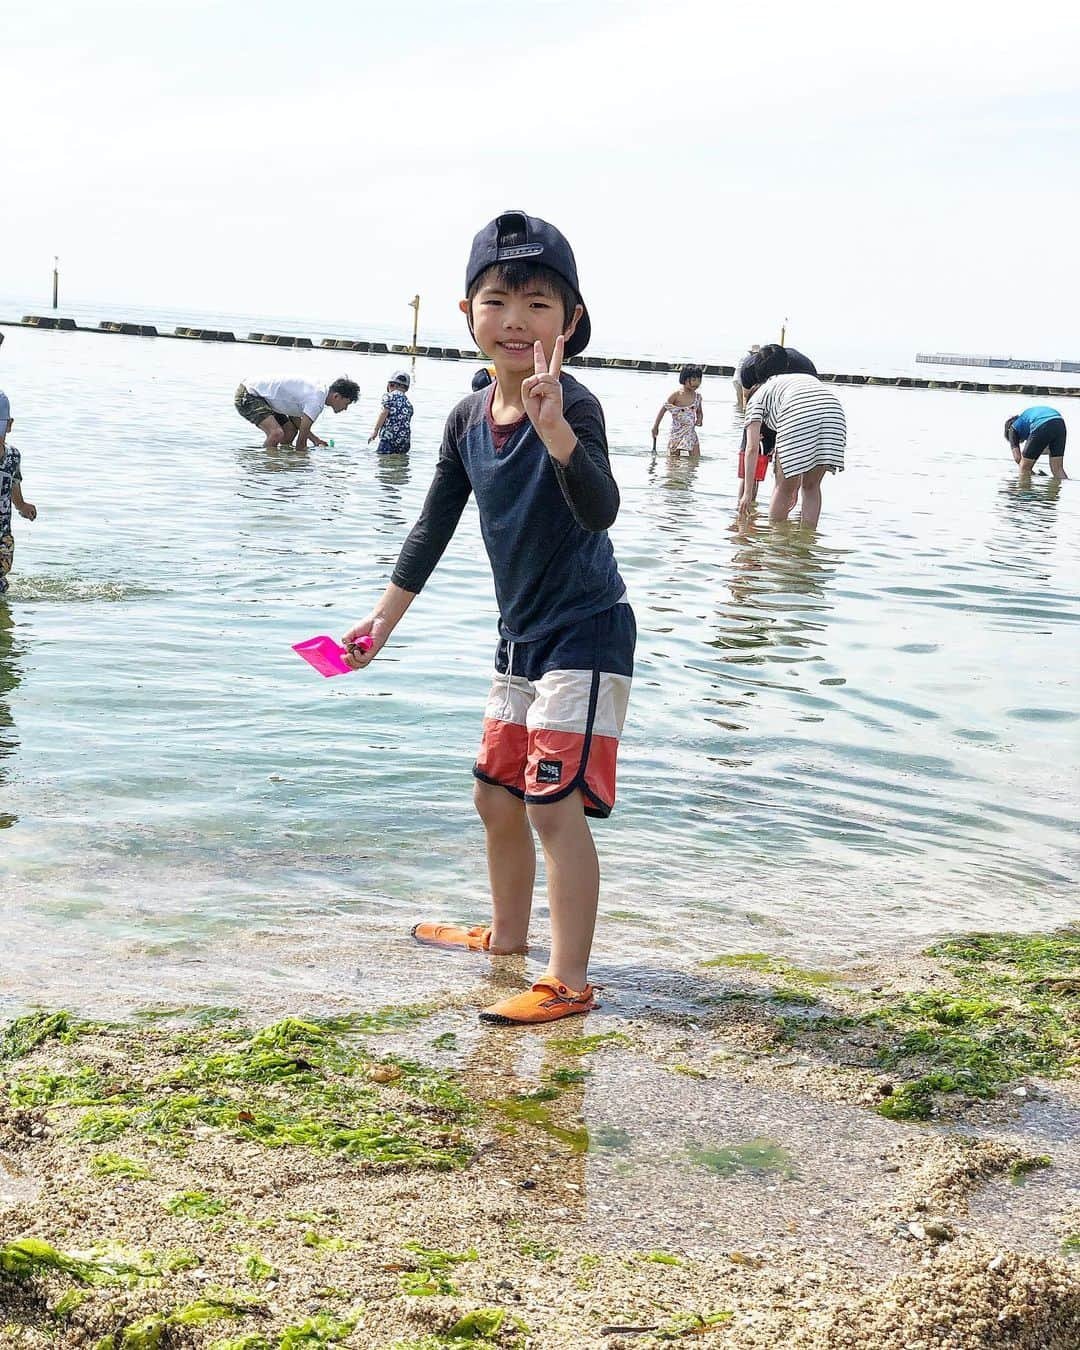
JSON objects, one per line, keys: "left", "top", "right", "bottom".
{"left": 0, "top": 329, "right": 1080, "bottom": 1011}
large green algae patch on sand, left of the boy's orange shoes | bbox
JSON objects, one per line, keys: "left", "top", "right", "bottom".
{"left": 7, "top": 1010, "right": 474, "bottom": 1169}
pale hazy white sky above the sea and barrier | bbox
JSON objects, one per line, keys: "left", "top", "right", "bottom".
{"left": 0, "top": 0, "right": 1080, "bottom": 359}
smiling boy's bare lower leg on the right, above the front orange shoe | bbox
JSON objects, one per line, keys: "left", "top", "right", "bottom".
{"left": 528, "top": 792, "right": 599, "bottom": 991}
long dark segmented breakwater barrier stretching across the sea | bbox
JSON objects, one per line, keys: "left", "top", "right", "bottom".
{"left": 0, "top": 315, "right": 1080, "bottom": 398}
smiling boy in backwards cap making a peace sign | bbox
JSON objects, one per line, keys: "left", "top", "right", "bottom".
{"left": 344, "top": 211, "right": 636, "bottom": 1023}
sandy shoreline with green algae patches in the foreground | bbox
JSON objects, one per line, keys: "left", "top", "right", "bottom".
{"left": 0, "top": 927, "right": 1080, "bottom": 1350}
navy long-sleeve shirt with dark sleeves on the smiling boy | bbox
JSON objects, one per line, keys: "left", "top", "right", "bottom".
{"left": 392, "top": 374, "right": 625, "bottom": 643}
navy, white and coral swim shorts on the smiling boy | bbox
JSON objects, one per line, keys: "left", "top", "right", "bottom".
{"left": 473, "top": 602, "right": 637, "bottom": 818}
